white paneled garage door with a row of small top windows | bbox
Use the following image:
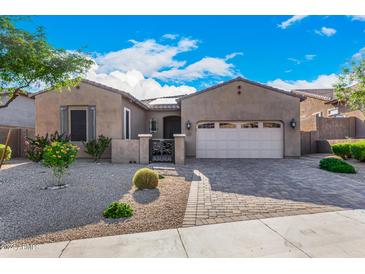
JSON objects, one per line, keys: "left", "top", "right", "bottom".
{"left": 196, "top": 121, "right": 283, "bottom": 158}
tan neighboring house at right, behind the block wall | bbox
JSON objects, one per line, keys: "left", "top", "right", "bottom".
{"left": 292, "top": 89, "right": 365, "bottom": 138}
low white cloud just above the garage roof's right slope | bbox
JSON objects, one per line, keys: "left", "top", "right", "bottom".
{"left": 267, "top": 73, "right": 337, "bottom": 91}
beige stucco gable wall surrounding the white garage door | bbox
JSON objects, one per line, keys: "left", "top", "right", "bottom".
{"left": 181, "top": 80, "right": 300, "bottom": 157}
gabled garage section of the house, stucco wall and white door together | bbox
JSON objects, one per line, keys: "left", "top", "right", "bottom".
{"left": 179, "top": 78, "right": 304, "bottom": 159}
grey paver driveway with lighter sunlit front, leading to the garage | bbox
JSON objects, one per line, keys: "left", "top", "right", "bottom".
{"left": 177, "top": 155, "right": 365, "bottom": 226}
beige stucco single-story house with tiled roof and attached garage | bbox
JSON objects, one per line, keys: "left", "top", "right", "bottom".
{"left": 33, "top": 77, "right": 303, "bottom": 161}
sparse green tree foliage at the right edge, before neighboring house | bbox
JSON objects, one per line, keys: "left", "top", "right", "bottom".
{"left": 334, "top": 58, "right": 365, "bottom": 112}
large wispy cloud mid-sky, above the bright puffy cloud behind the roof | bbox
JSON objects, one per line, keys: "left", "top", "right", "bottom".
{"left": 95, "top": 38, "right": 198, "bottom": 76}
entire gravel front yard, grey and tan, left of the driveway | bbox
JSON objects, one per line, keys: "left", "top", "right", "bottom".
{"left": 0, "top": 160, "right": 190, "bottom": 244}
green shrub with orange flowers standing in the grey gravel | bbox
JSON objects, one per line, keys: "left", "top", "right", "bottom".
{"left": 43, "top": 141, "right": 79, "bottom": 185}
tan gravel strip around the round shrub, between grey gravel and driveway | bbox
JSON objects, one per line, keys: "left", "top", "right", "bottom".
{"left": 11, "top": 171, "right": 190, "bottom": 245}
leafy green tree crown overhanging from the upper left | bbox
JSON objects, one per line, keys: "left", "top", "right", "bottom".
{"left": 0, "top": 16, "right": 93, "bottom": 108}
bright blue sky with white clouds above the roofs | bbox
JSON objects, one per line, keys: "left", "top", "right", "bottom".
{"left": 21, "top": 16, "right": 365, "bottom": 98}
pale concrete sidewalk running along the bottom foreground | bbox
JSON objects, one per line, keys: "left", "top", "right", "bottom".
{"left": 0, "top": 210, "right": 365, "bottom": 258}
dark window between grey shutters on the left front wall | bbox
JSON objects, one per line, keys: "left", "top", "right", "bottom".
{"left": 69, "top": 108, "right": 87, "bottom": 142}
